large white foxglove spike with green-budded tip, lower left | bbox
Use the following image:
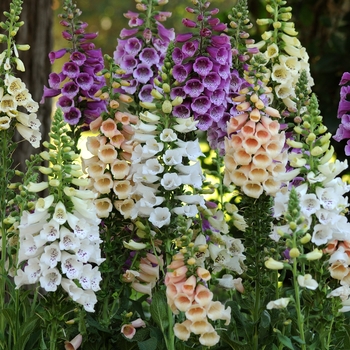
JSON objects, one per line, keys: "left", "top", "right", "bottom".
{"left": 15, "top": 110, "right": 104, "bottom": 312}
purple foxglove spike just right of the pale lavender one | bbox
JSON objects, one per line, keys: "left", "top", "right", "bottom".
{"left": 171, "top": 1, "right": 232, "bottom": 140}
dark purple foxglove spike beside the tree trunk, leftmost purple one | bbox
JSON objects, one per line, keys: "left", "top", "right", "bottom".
{"left": 42, "top": 1, "right": 106, "bottom": 125}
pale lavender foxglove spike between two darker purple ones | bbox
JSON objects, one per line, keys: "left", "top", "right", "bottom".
{"left": 113, "top": 1, "right": 175, "bottom": 103}
